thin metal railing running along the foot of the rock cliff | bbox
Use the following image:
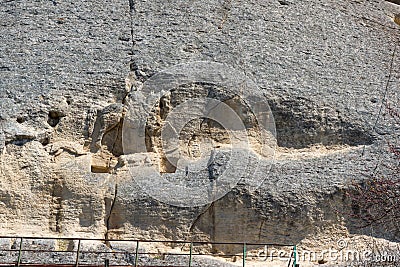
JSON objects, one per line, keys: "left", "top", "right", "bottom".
{"left": 0, "top": 236, "right": 298, "bottom": 267}
